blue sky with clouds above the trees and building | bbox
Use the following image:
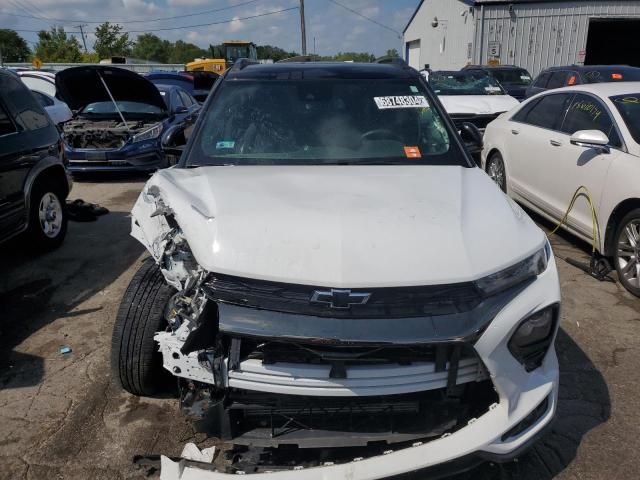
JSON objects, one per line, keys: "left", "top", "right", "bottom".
{"left": 0, "top": 0, "right": 419, "bottom": 55}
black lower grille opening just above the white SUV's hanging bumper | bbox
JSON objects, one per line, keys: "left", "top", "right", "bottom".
{"left": 218, "top": 380, "right": 499, "bottom": 449}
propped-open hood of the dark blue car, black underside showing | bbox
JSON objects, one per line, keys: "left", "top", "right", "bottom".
{"left": 56, "top": 65, "right": 167, "bottom": 111}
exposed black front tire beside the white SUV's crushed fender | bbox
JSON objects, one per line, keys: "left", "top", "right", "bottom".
{"left": 111, "top": 258, "right": 177, "bottom": 396}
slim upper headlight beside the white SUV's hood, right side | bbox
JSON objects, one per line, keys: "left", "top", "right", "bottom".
{"left": 476, "top": 240, "right": 551, "bottom": 296}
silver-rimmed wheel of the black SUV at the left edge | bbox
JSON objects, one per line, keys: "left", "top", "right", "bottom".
{"left": 26, "top": 183, "right": 68, "bottom": 252}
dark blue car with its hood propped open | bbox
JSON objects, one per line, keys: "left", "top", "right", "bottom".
{"left": 55, "top": 65, "right": 200, "bottom": 172}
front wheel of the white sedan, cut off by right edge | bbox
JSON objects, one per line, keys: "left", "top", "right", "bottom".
{"left": 614, "top": 208, "right": 640, "bottom": 297}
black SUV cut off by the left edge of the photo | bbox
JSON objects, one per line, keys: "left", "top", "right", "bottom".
{"left": 0, "top": 69, "right": 71, "bottom": 250}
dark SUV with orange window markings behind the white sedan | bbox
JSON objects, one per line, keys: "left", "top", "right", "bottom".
{"left": 527, "top": 65, "right": 640, "bottom": 98}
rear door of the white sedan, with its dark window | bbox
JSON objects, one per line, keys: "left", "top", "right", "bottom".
{"left": 505, "top": 93, "right": 573, "bottom": 212}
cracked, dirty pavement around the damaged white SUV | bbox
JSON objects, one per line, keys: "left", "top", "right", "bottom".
{"left": 0, "top": 177, "right": 640, "bottom": 480}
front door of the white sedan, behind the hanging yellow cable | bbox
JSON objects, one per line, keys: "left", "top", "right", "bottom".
{"left": 548, "top": 92, "right": 623, "bottom": 238}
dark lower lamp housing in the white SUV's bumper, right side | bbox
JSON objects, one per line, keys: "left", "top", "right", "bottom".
{"left": 507, "top": 305, "right": 558, "bottom": 372}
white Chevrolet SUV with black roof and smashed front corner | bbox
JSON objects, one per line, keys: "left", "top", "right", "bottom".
{"left": 112, "top": 61, "right": 560, "bottom": 479}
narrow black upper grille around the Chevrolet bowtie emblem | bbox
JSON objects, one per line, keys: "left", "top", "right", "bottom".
{"left": 204, "top": 274, "right": 482, "bottom": 318}
